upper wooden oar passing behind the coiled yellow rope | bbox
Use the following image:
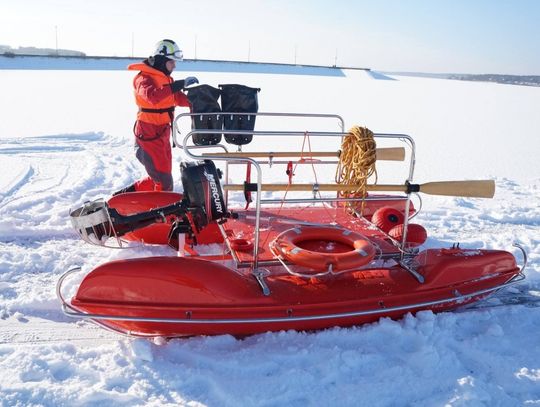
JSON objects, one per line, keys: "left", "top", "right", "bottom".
{"left": 203, "top": 147, "right": 405, "bottom": 161}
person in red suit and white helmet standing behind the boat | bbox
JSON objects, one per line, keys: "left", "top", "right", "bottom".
{"left": 113, "top": 39, "right": 199, "bottom": 196}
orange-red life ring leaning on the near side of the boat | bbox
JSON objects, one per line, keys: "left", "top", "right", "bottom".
{"left": 270, "top": 226, "right": 375, "bottom": 271}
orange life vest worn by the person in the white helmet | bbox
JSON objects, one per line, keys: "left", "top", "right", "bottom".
{"left": 128, "top": 62, "right": 178, "bottom": 125}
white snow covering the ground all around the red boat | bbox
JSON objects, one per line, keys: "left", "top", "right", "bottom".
{"left": 0, "top": 59, "right": 540, "bottom": 406}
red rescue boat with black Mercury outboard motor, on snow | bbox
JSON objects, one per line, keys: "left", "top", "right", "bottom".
{"left": 57, "top": 114, "right": 526, "bottom": 337}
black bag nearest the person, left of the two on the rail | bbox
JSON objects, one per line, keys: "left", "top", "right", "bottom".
{"left": 187, "top": 85, "right": 223, "bottom": 146}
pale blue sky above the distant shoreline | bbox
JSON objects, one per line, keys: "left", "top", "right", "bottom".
{"left": 0, "top": 0, "right": 540, "bottom": 75}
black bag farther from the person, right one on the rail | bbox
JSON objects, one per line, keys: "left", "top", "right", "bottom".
{"left": 219, "top": 85, "right": 260, "bottom": 146}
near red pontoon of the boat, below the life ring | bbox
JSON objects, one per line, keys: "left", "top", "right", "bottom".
{"left": 71, "top": 249, "right": 519, "bottom": 337}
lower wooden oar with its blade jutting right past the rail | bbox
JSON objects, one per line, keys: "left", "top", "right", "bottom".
{"left": 223, "top": 180, "right": 495, "bottom": 198}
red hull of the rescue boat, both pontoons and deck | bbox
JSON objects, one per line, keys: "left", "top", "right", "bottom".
{"left": 63, "top": 193, "right": 520, "bottom": 337}
